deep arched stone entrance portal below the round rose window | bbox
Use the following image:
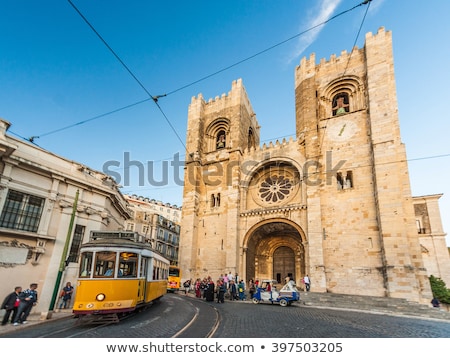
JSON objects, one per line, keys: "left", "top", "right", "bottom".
{"left": 245, "top": 220, "right": 306, "bottom": 284}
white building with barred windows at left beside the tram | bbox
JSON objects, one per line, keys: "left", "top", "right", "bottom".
{"left": 0, "top": 119, "right": 131, "bottom": 317}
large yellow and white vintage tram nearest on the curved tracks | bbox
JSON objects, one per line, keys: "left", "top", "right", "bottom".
{"left": 73, "top": 231, "right": 169, "bottom": 320}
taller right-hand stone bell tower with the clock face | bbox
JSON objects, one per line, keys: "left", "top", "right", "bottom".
{"left": 295, "top": 28, "right": 431, "bottom": 303}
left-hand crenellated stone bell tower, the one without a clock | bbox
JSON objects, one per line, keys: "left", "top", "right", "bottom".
{"left": 180, "top": 79, "right": 260, "bottom": 279}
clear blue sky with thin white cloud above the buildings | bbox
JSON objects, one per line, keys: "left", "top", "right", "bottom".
{"left": 0, "top": 0, "right": 450, "bottom": 245}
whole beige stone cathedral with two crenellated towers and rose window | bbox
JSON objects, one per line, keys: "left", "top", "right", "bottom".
{"left": 179, "top": 28, "right": 450, "bottom": 303}
